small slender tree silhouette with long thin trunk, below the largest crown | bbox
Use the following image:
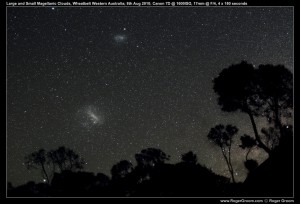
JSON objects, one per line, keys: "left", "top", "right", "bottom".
{"left": 207, "top": 125, "right": 238, "bottom": 183}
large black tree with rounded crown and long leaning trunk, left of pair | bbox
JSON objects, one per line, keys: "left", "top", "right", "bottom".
{"left": 213, "top": 61, "right": 271, "bottom": 154}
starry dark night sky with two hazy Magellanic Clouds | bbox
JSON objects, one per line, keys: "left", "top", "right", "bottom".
{"left": 7, "top": 7, "right": 293, "bottom": 185}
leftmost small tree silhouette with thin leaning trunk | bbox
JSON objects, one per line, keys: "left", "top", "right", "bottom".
{"left": 25, "top": 149, "right": 50, "bottom": 183}
